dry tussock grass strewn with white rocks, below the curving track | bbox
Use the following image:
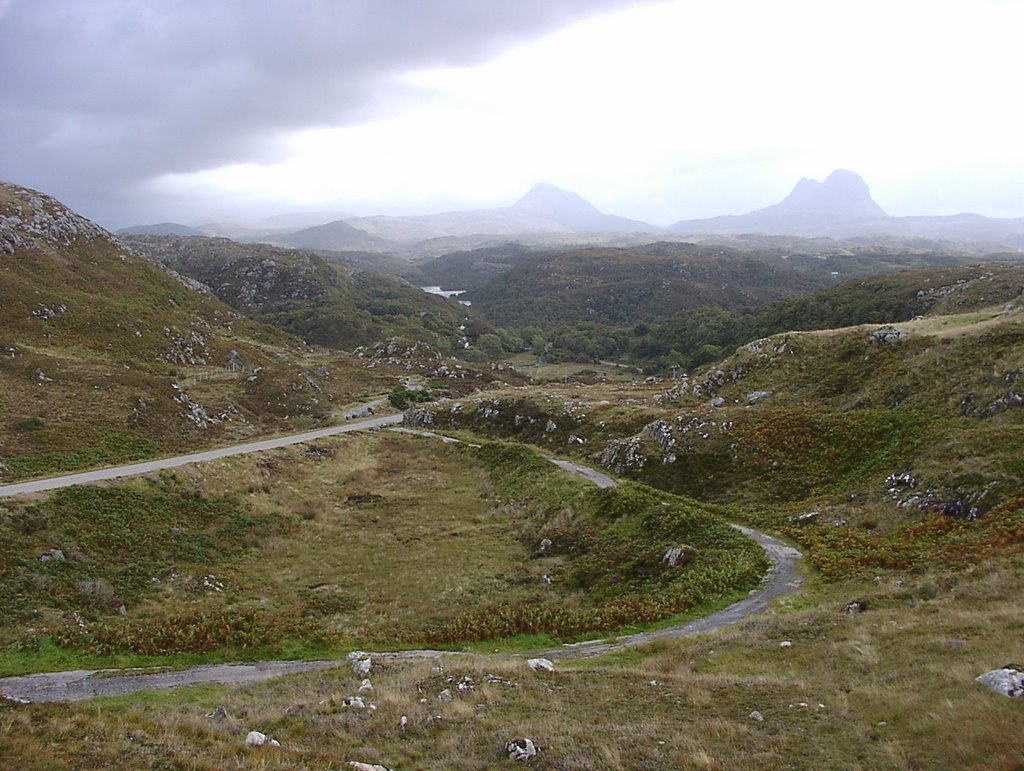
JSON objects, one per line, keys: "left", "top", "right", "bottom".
{"left": 6, "top": 559, "right": 1024, "bottom": 771}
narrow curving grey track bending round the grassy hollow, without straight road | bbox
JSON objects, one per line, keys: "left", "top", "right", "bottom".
{"left": 0, "top": 430, "right": 801, "bottom": 701}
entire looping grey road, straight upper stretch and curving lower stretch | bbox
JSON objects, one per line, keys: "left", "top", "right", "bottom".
{"left": 0, "top": 423, "right": 801, "bottom": 702}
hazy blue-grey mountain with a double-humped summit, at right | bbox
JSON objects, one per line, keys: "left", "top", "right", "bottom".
{"left": 668, "top": 169, "right": 1024, "bottom": 244}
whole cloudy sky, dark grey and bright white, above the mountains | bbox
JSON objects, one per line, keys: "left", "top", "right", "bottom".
{"left": 0, "top": 0, "right": 1024, "bottom": 227}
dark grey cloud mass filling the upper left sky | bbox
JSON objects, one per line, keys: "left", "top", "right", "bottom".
{"left": 0, "top": 0, "right": 631, "bottom": 221}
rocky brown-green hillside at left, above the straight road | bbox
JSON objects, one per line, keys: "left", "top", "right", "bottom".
{"left": 0, "top": 185, "right": 415, "bottom": 481}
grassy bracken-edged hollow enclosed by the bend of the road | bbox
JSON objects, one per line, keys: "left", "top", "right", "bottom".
{"left": 0, "top": 434, "right": 766, "bottom": 673}
